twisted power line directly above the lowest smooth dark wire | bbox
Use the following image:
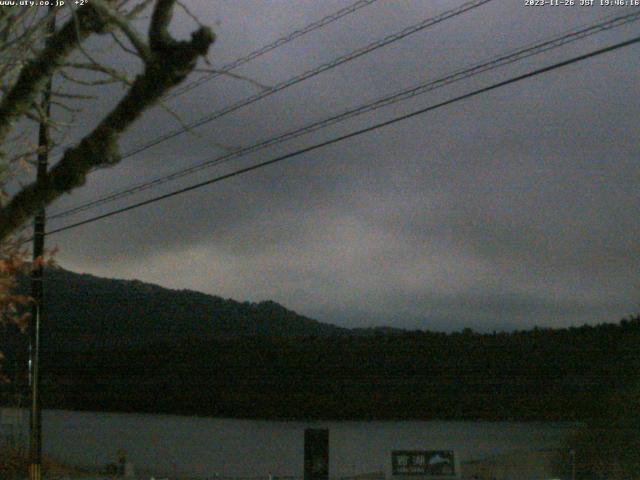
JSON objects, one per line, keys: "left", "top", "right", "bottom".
{"left": 49, "top": 12, "right": 640, "bottom": 219}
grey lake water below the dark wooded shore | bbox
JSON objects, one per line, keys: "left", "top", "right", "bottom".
{"left": 1, "top": 410, "right": 575, "bottom": 477}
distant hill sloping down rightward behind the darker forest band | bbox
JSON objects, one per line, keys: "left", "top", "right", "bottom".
{"left": 13, "top": 268, "right": 348, "bottom": 349}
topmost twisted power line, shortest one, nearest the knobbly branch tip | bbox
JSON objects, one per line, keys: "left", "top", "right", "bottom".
{"left": 165, "top": 0, "right": 378, "bottom": 99}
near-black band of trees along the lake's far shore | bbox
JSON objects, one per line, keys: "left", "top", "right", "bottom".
{"left": 14, "top": 316, "right": 640, "bottom": 421}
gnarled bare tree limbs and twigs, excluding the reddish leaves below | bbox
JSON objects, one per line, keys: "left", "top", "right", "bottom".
{"left": 0, "top": 0, "right": 214, "bottom": 241}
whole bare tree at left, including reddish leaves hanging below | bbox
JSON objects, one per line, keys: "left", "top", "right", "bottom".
{"left": 0, "top": 0, "right": 214, "bottom": 348}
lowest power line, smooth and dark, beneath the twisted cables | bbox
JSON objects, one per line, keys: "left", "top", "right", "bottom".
{"left": 42, "top": 32, "right": 640, "bottom": 239}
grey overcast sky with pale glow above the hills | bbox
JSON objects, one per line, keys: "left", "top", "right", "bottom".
{"left": 37, "top": 0, "right": 640, "bottom": 331}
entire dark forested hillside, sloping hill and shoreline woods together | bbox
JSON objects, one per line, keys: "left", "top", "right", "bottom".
{"left": 2, "top": 271, "right": 640, "bottom": 420}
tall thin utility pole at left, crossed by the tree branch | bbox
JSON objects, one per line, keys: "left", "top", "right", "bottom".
{"left": 29, "top": 6, "right": 56, "bottom": 480}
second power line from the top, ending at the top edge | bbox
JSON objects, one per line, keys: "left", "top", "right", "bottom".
{"left": 115, "top": 0, "right": 493, "bottom": 159}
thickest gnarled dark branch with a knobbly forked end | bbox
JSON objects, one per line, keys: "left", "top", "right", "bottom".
{"left": 0, "top": 0, "right": 215, "bottom": 241}
